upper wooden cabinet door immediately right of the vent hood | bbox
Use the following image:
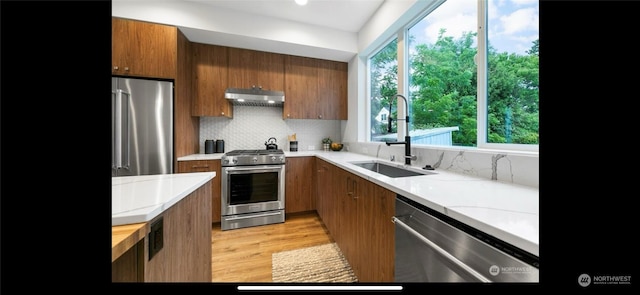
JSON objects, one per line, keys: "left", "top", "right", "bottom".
{"left": 282, "top": 55, "right": 318, "bottom": 119}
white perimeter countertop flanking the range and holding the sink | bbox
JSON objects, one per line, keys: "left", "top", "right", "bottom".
{"left": 178, "top": 151, "right": 540, "bottom": 256}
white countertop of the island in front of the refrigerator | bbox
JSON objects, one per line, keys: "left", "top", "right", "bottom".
{"left": 111, "top": 172, "right": 216, "bottom": 226}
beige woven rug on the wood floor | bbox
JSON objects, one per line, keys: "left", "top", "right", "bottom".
{"left": 271, "top": 243, "right": 358, "bottom": 283}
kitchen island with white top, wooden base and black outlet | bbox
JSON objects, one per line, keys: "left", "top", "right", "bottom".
{"left": 112, "top": 172, "right": 216, "bottom": 282}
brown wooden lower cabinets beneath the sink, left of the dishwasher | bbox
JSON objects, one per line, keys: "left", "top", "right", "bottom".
{"left": 316, "top": 159, "right": 396, "bottom": 282}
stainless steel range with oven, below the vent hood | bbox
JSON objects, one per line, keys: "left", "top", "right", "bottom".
{"left": 220, "top": 149, "right": 285, "bottom": 230}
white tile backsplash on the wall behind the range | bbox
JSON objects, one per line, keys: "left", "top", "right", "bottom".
{"left": 200, "top": 105, "right": 341, "bottom": 154}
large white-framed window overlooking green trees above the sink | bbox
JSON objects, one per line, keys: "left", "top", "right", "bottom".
{"left": 369, "top": 0, "right": 539, "bottom": 151}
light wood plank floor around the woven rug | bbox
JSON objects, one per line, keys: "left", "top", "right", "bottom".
{"left": 211, "top": 211, "right": 334, "bottom": 282}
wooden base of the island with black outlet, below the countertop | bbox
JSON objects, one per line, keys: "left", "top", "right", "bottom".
{"left": 111, "top": 181, "right": 212, "bottom": 282}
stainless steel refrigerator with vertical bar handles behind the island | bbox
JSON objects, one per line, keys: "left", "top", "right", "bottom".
{"left": 111, "top": 77, "right": 173, "bottom": 177}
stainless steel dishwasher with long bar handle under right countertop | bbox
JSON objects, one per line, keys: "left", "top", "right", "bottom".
{"left": 393, "top": 195, "right": 539, "bottom": 283}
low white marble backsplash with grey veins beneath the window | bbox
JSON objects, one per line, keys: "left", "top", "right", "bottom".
{"left": 345, "top": 142, "right": 540, "bottom": 187}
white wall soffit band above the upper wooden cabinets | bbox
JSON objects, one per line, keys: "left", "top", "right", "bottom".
{"left": 111, "top": 0, "right": 358, "bottom": 62}
